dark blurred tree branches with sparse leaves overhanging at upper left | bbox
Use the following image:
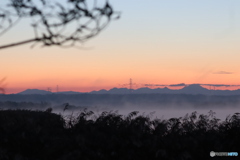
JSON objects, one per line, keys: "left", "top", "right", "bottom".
{"left": 0, "top": 0, "right": 120, "bottom": 49}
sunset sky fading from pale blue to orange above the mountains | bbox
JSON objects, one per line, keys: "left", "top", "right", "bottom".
{"left": 0, "top": 0, "right": 240, "bottom": 94}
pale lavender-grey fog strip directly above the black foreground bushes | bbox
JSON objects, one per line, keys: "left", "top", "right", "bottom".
{"left": 53, "top": 103, "right": 240, "bottom": 120}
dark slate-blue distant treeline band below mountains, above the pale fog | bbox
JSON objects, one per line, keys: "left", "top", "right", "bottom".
{"left": 0, "top": 93, "right": 240, "bottom": 108}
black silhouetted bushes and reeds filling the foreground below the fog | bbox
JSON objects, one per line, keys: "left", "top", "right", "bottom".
{"left": 0, "top": 108, "right": 240, "bottom": 160}
